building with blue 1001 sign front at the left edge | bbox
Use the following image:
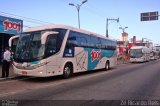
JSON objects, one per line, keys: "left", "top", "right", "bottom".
{"left": 0, "top": 16, "right": 23, "bottom": 62}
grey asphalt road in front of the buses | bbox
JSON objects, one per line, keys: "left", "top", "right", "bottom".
{"left": 0, "top": 60, "right": 160, "bottom": 106}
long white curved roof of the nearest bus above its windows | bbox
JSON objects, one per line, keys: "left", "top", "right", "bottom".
{"left": 23, "top": 24, "right": 116, "bottom": 41}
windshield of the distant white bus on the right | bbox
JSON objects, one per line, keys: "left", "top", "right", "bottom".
{"left": 130, "top": 49, "right": 143, "bottom": 58}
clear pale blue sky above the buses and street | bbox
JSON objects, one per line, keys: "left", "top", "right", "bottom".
{"left": 0, "top": 0, "right": 160, "bottom": 44}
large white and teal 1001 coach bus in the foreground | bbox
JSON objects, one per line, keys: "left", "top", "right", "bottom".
{"left": 9, "top": 25, "right": 117, "bottom": 78}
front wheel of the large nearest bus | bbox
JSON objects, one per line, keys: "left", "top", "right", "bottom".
{"left": 63, "top": 64, "right": 73, "bottom": 78}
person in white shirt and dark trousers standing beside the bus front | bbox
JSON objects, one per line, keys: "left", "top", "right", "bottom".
{"left": 2, "top": 47, "right": 11, "bottom": 78}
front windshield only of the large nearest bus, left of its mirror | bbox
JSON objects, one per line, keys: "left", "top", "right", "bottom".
{"left": 14, "top": 32, "right": 45, "bottom": 62}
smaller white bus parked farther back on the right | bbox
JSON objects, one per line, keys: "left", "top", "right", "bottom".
{"left": 129, "top": 46, "right": 152, "bottom": 62}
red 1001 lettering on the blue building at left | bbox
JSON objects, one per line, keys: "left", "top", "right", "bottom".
{"left": 3, "top": 19, "right": 21, "bottom": 32}
